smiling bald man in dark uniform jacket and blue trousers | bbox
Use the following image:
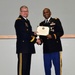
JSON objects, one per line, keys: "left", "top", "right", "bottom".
{"left": 38, "top": 8, "right": 64, "bottom": 75}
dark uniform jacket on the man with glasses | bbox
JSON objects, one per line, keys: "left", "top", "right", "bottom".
{"left": 15, "top": 16, "right": 36, "bottom": 53}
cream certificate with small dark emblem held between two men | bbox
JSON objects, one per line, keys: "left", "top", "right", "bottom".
{"left": 37, "top": 26, "right": 49, "bottom": 36}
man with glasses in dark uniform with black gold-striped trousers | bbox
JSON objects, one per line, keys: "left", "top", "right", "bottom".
{"left": 15, "top": 6, "right": 36, "bottom": 75}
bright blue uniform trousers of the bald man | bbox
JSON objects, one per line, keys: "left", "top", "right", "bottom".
{"left": 44, "top": 52, "right": 62, "bottom": 75}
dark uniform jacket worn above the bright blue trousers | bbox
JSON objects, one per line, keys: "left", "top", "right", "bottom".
{"left": 40, "top": 18, "right": 64, "bottom": 53}
